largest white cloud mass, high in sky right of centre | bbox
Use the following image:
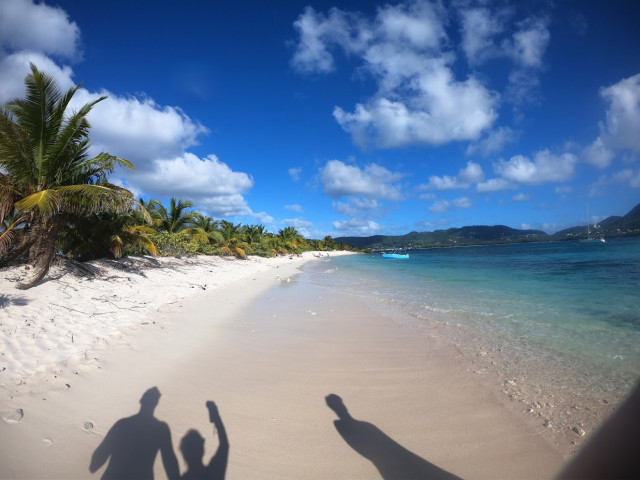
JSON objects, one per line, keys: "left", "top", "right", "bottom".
{"left": 292, "top": 0, "right": 497, "bottom": 148}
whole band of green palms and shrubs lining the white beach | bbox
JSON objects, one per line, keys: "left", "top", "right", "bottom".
{"left": 0, "top": 64, "right": 346, "bottom": 288}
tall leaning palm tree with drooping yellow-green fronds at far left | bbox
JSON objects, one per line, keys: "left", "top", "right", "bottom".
{"left": 0, "top": 64, "right": 138, "bottom": 288}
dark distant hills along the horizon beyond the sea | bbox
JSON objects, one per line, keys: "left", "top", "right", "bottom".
{"left": 335, "top": 203, "right": 640, "bottom": 250}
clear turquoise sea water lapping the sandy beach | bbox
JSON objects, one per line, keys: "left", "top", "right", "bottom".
{"left": 305, "top": 238, "right": 640, "bottom": 399}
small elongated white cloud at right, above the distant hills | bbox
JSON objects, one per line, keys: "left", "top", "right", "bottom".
{"left": 494, "top": 150, "right": 578, "bottom": 185}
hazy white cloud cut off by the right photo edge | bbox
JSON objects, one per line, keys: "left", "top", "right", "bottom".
{"left": 600, "top": 73, "right": 640, "bottom": 152}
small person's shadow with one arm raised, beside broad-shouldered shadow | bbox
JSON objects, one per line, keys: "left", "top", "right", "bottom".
{"left": 180, "top": 401, "right": 229, "bottom": 480}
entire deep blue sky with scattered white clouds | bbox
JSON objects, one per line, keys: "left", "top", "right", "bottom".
{"left": 0, "top": 0, "right": 640, "bottom": 238}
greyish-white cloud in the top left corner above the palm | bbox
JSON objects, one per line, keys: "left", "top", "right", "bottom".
{"left": 0, "top": 0, "right": 80, "bottom": 59}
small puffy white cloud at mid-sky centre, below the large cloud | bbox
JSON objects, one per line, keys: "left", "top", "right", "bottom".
{"left": 320, "top": 160, "right": 403, "bottom": 200}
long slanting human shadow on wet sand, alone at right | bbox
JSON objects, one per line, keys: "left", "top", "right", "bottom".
{"left": 325, "top": 393, "right": 460, "bottom": 480}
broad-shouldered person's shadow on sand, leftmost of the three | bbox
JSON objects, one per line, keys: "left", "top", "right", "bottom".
{"left": 89, "top": 387, "right": 180, "bottom": 480}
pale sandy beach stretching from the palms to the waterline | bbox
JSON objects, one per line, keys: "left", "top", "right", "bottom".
{"left": 0, "top": 253, "right": 563, "bottom": 479}
